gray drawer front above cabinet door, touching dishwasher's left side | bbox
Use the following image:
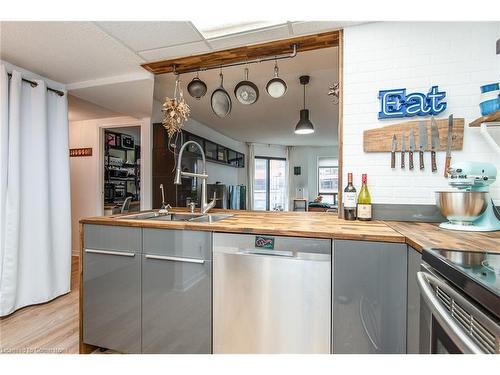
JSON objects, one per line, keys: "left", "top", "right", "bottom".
{"left": 143, "top": 229, "right": 212, "bottom": 260}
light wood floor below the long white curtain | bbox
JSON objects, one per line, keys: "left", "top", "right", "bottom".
{"left": 0, "top": 257, "right": 79, "bottom": 353}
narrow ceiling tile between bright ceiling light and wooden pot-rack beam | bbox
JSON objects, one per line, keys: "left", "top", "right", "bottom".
{"left": 208, "top": 25, "right": 290, "bottom": 50}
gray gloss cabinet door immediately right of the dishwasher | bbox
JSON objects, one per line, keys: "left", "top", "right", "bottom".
{"left": 332, "top": 240, "right": 407, "bottom": 354}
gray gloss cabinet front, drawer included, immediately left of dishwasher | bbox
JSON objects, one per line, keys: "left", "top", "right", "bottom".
{"left": 142, "top": 229, "right": 212, "bottom": 354}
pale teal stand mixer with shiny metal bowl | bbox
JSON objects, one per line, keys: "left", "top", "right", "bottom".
{"left": 436, "top": 162, "right": 500, "bottom": 232}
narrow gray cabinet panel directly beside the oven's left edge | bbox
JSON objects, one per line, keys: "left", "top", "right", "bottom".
{"left": 406, "top": 246, "right": 422, "bottom": 354}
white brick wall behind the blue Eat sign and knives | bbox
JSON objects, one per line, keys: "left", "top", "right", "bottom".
{"left": 343, "top": 22, "right": 500, "bottom": 204}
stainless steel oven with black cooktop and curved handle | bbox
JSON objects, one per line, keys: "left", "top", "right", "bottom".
{"left": 417, "top": 250, "right": 500, "bottom": 354}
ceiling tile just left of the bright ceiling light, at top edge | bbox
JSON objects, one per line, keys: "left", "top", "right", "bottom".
{"left": 97, "top": 21, "right": 202, "bottom": 52}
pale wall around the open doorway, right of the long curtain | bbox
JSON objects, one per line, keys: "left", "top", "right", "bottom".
{"left": 69, "top": 117, "right": 151, "bottom": 252}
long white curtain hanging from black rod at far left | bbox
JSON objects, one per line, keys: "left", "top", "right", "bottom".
{"left": 0, "top": 64, "right": 71, "bottom": 316}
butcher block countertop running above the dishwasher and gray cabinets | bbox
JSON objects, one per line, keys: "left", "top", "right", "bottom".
{"left": 80, "top": 209, "right": 500, "bottom": 253}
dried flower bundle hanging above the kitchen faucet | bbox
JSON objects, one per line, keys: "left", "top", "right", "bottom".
{"left": 162, "top": 76, "right": 190, "bottom": 138}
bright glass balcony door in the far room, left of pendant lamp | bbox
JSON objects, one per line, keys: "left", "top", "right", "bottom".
{"left": 253, "top": 157, "right": 286, "bottom": 211}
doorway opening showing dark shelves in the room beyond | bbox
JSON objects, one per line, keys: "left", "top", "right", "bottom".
{"left": 102, "top": 126, "right": 141, "bottom": 215}
